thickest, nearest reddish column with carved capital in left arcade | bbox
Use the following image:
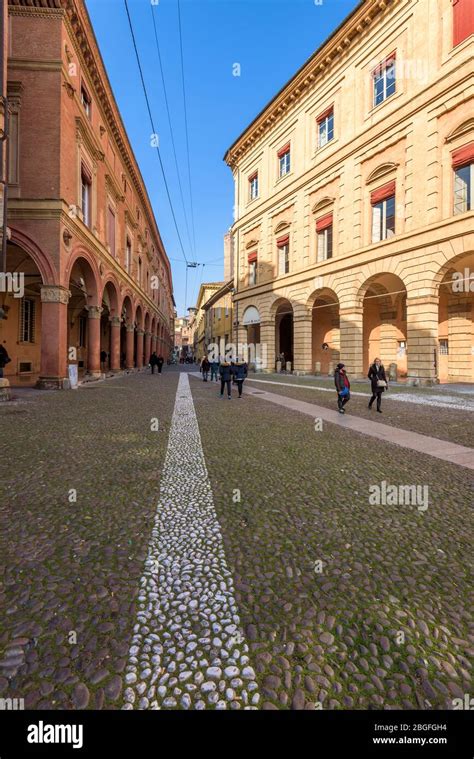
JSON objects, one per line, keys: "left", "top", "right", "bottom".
{"left": 37, "top": 285, "right": 70, "bottom": 388}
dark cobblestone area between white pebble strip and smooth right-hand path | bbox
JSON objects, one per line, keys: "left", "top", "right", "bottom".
{"left": 191, "top": 379, "right": 474, "bottom": 709}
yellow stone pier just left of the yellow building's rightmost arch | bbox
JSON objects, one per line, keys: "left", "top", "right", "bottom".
{"left": 407, "top": 295, "right": 439, "bottom": 385}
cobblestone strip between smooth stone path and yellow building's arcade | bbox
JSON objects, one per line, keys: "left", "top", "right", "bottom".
{"left": 244, "top": 376, "right": 474, "bottom": 448}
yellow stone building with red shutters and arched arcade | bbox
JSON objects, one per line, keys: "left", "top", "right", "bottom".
{"left": 225, "top": 0, "right": 474, "bottom": 384}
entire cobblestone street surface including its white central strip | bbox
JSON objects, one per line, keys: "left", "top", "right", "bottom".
{"left": 0, "top": 367, "right": 474, "bottom": 710}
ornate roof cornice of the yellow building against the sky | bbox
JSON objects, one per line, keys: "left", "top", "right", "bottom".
{"left": 224, "top": 0, "right": 394, "bottom": 170}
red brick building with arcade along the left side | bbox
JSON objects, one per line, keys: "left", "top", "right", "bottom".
{"left": 0, "top": 0, "right": 174, "bottom": 387}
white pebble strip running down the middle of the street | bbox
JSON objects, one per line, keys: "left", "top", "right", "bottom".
{"left": 123, "top": 372, "right": 260, "bottom": 709}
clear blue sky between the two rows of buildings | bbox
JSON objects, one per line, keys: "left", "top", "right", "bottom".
{"left": 86, "top": 0, "right": 358, "bottom": 315}
